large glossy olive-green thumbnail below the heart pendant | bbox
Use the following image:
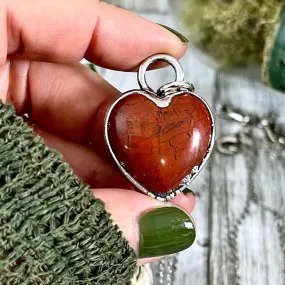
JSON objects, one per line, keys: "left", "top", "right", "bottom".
{"left": 139, "top": 207, "right": 196, "bottom": 258}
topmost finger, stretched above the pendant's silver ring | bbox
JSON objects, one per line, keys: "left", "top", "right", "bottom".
{"left": 5, "top": 0, "right": 186, "bottom": 70}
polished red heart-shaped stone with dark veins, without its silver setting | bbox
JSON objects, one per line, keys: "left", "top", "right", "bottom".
{"left": 108, "top": 94, "right": 212, "bottom": 193}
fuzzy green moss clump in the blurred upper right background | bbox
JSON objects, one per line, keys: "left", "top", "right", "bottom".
{"left": 181, "top": 0, "right": 284, "bottom": 67}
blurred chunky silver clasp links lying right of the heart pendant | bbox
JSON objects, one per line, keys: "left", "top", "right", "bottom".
{"left": 216, "top": 105, "right": 285, "bottom": 159}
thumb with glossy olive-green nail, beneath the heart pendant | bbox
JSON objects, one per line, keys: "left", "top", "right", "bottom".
{"left": 92, "top": 189, "right": 196, "bottom": 258}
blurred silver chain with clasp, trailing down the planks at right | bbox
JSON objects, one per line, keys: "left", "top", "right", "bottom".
{"left": 217, "top": 105, "right": 285, "bottom": 285}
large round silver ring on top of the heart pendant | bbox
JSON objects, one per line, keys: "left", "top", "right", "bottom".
{"left": 138, "top": 54, "right": 184, "bottom": 92}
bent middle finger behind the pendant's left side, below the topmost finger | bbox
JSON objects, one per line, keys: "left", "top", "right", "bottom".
{"left": 8, "top": 61, "right": 115, "bottom": 147}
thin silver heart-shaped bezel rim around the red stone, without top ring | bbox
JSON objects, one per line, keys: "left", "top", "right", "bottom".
{"left": 104, "top": 89, "right": 215, "bottom": 201}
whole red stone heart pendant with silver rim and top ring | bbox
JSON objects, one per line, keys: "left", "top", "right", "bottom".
{"left": 105, "top": 54, "right": 214, "bottom": 201}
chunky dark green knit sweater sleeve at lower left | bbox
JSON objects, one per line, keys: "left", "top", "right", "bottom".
{"left": 0, "top": 103, "right": 136, "bottom": 285}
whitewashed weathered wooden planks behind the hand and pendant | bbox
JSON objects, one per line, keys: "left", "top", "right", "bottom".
{"left": 102, "top": 0, "right": 285, "bottom": 285}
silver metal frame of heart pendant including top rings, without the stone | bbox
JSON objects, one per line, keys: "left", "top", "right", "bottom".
{"left": 104, "top": 54, "right": 215, "bottom": 201}
